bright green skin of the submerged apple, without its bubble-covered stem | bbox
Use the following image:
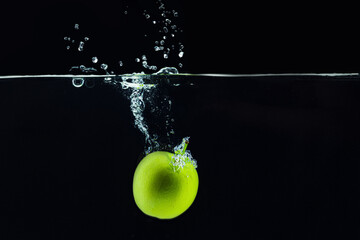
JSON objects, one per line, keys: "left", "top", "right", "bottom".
{"left": 133, "top": 151, "right": 199, "bottom": 219}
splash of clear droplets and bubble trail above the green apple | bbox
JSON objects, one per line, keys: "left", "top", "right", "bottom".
{"left": 64, "top": 0, "right": 187, "bottom": 154}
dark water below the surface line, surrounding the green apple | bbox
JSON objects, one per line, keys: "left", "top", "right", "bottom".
{"left": 0, "top": 76, "right": 360, "bottom": 239}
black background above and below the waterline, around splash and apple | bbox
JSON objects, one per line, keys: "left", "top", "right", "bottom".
{"left": 0, "top": 1, "right": 360, "bottom": 239}
